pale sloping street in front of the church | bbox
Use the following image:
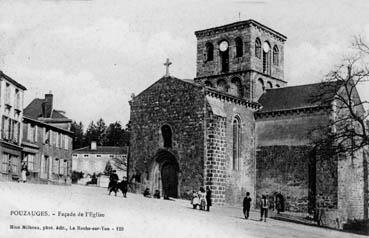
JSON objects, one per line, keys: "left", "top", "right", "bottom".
{"left": 0, "top": 182, "right": 365, "bottom": 238}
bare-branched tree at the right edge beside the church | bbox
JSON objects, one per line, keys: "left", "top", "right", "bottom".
{"left": 312, "top": 37, "right": 369, "bottom": 157}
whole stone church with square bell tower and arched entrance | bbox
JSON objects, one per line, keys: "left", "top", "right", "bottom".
{"left": 128, "top": 20, "right": 368, "bottom": 227}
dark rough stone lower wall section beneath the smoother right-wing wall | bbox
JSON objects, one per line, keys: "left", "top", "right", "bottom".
{"left": 256, "top": 146, "right": 315, "bottom": 213}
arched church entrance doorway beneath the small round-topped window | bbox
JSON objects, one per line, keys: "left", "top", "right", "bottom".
{"left": 151, "top": 150, "right": 179, "bottom": 198}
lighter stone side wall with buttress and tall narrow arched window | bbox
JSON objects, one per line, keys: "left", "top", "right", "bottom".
{"left": 205, "top": 96, "right": 255, "bottom": 205}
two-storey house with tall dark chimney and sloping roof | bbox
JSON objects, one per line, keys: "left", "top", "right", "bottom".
{"left": 22, "top": 93, "right": 73, "bottom": 184}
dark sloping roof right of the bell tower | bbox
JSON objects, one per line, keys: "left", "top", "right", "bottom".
{"left": 258, "top": 81, "right": 340, "bottom": 113}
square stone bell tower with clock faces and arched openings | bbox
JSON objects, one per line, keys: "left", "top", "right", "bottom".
{"left": 195, "top": 19, "right": 287, "bottom": 101}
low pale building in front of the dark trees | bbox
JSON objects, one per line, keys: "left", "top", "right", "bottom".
{"left": 72, "top": 141, "right": 128, "bottom": 183}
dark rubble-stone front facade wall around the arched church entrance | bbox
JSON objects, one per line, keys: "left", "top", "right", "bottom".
{"left": 128, "top": 77, "right": 205, "bottom": 197}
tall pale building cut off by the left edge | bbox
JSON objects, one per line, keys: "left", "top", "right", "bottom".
{"left": 0, "top": 71, "right": 26, "bottom": 180}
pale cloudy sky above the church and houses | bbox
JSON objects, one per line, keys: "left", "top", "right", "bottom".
{"left": 0, "top": 0, "right": 369, "bottom": 126}
